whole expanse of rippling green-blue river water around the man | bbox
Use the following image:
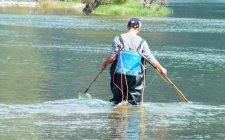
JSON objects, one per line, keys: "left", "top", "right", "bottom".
{"left": 0, "top": 0, "right": 225, "bottom": 140}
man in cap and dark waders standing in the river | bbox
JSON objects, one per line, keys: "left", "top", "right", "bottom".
{"left": 102, "top": 18, "right": 167, "bottom": 105}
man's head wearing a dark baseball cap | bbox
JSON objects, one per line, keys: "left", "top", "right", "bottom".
{"left": 127, "top": 18, "right": 141, "bottom": 33}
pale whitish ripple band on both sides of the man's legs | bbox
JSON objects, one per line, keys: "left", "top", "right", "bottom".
{"left": 0, "top": 99, "right": 225, "bottom": 119}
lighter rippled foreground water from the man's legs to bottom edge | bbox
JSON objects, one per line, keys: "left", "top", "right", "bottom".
{"left": 0, "top": 99, "right": 225, "bottom": 139}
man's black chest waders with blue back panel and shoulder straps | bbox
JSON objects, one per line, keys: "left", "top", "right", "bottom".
{"left": 110, "top": 36, "right": 145, "bottom": 105}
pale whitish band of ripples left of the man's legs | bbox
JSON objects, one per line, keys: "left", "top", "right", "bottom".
{"left": 0, "top": 99, "right": 110, "bottom": 119}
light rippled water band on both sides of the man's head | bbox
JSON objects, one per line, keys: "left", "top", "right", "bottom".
{"left": 0, "top": 14, "right": 225, "bottom": 33}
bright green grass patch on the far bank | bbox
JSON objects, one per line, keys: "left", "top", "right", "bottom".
{"left": 93, "top": 2, "right": 172, "bottom": 16}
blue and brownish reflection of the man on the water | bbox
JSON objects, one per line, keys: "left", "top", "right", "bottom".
{"left": 109, "top": 106, "right": 148, "bottom": 140}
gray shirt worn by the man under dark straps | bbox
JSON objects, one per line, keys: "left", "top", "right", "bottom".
{"left": 110, "top": 33, "right": 158, "bottom": 64}
